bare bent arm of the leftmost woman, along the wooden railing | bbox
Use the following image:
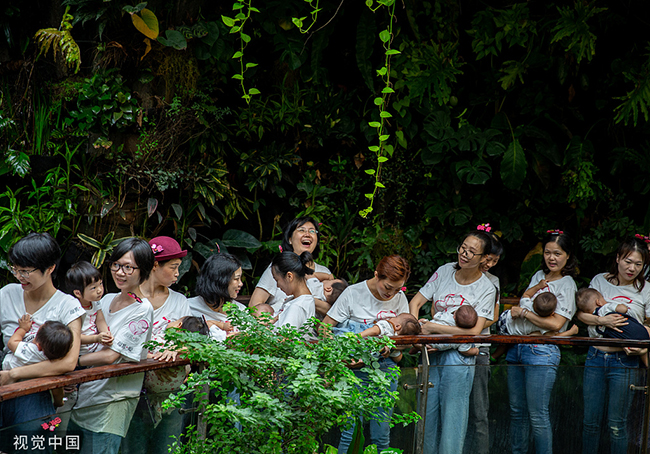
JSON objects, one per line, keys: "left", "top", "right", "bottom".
{"left": 0, "top": 317, "right": 81, "bottom": 385}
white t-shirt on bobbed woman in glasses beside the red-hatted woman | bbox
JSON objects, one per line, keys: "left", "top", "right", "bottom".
{"left": 72, "top": 293, "right": 153, "bottom": 437}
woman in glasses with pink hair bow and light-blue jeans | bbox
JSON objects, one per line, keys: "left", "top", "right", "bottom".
{"left": 409, "top": 230, "right": 496, "bottom": 454}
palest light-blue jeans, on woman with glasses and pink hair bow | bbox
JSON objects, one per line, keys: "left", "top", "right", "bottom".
{"left": 424, "top": 349, "right": 475, "bottom": 454}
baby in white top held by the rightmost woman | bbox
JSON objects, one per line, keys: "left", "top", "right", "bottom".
{"left": 576, "top": 288, "right": 650, "bottom": 367}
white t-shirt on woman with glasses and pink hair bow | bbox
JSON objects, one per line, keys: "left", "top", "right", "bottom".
{"left": 420, "top": 263, "right": 497, "bottom": 320}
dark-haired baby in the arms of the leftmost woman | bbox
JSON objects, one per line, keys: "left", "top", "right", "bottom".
{"left": 2, "top": 314, "right": 73, "bottom": 407}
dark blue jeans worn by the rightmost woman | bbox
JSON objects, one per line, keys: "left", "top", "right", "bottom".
{"left": 582, "top": 347, "right": 639, "bottom": 454}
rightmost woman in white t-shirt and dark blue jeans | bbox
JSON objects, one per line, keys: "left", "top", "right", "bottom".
{"left": 578, "top": 235, "right": 650, "bottom": 454}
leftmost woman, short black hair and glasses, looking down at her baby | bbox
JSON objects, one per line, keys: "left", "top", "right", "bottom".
{"left": 0, "top": 233, "right": 84, "bottom": 452}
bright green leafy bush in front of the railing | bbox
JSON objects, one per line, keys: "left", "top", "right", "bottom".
{"left": 165, "top": 308, "right": 417, "bottom": 454}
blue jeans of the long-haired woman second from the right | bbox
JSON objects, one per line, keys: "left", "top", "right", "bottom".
{"left": 506, "top": 344, "right": 560, "bottom": 454}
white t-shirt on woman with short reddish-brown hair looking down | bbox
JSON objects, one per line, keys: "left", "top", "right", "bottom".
{"left": 327, "top": 281, "right": 409, "bottom": 324}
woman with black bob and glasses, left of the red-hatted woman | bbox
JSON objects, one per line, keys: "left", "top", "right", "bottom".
{"left": 68, "top": 238, "right": 154, "bottom": 454}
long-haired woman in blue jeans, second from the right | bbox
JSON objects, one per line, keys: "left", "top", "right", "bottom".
{"left": 506, "top": 230, "right": 577, "bottom": 454}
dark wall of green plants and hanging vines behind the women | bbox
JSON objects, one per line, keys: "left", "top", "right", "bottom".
{"left": 0, "top": 0, "right": 650, "bottom": 291}
